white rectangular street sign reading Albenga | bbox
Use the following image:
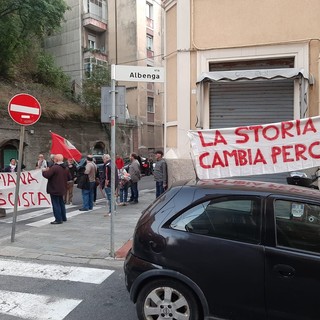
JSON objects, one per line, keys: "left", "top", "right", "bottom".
{"left": 112, "top": 65, "right": 164, "bottom": 82}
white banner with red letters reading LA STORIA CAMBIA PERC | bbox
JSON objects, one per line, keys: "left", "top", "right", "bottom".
{"left": 188, "top": 116, "right": 320, "bottom": 179}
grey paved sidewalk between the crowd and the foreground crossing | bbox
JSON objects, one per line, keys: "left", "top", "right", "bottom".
{"left": 0, "top": 190, "right": 155, "bottom": 267}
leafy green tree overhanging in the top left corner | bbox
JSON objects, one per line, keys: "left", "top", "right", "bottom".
{"left": 0, "top": 0, "right": 69, "bottom": 76}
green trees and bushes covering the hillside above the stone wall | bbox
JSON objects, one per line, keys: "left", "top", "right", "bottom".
{"left": 0, "top": 0, "right": 111, "bottom": 118}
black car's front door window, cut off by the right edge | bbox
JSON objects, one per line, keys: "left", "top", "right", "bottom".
{"left": 274, "top": 200, "right": 320, "bottom": 253}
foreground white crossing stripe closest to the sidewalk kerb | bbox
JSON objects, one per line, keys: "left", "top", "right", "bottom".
{"left": 0, "top": 260, "right": 113, "bottom": 284}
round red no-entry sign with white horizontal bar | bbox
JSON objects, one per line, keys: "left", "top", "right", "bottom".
{"left": 8, "top": 93, "right": 41, "bottom": 126}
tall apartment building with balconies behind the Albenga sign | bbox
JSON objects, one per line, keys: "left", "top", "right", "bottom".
{"left": 45, "top": 0, "right": 164, "bottom": 157}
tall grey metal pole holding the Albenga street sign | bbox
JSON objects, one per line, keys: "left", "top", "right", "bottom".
{"left": 110, "top": 64, "right": 116, "bottom": 257}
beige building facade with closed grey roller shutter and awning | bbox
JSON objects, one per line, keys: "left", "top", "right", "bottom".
{"left": 164, "top": 0, "right": 320, "bottom": 181}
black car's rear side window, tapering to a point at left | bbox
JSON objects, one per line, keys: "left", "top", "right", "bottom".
{"left": 170, "top": 197, "right": 261, "bottom": 243}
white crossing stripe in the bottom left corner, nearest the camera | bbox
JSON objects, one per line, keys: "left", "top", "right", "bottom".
{"left": 0, "top": 290, "right": 82, "bottom": 320}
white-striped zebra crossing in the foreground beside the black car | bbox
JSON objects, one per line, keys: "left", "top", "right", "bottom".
{"left": 0, "top": 259, "right": 114, "bottom": 320}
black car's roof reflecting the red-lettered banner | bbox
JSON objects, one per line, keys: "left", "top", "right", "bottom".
{"left": 178, "top": 178, "right": 320, "bottom": 201}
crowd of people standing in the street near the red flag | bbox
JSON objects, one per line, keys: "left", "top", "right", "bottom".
{"left": 3, "top": 151, "right": 168, "bottom": 224}
